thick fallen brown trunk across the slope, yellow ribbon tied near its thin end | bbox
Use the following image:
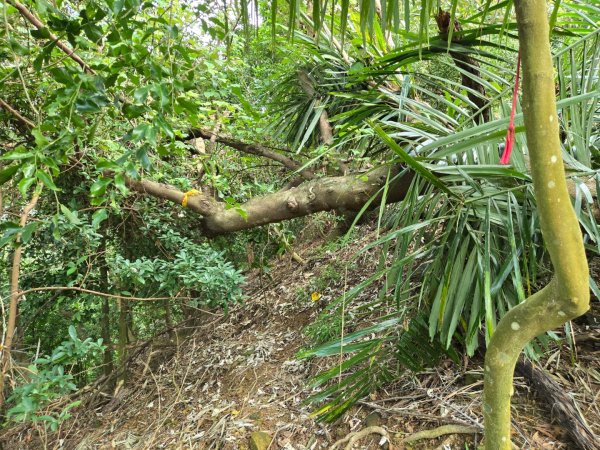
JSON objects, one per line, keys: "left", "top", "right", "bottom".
{"left": 128, "top": 166, "right": 412, "bottom": 235}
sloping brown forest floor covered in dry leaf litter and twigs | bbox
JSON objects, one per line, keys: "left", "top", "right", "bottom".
{"left": 0, "top": 221, "right": 600, "bottom": 450}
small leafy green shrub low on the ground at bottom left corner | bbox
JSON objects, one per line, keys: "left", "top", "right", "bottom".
{"left": 6, "top": 325, "right": 104, "bottom": 431}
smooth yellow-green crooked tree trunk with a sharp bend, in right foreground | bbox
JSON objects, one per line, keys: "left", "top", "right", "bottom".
{"left": 483, "top": 0, "right": 589, "bottom": 450}
